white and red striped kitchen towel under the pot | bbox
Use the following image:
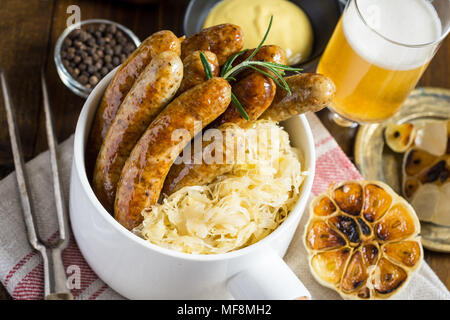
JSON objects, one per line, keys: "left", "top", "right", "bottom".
{"left": 0, "top": 114, "right": 450, "bottom": 299}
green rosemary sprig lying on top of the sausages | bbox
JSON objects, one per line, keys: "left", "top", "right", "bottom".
{"left": 200, "top": 16, "right": 302, "bottom": 120}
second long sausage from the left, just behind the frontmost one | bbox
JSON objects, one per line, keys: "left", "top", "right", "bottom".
{"left": 93, "top": 51, "right": 183, "bottom": 213}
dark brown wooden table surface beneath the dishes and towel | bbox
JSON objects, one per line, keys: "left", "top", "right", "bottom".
{"left": 0, "top": 0, "right": 450, "bottom": 299}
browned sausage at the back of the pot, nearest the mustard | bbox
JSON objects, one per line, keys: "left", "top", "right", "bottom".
{"left": 181, "top": 23, "right": 244, "bottom": 65}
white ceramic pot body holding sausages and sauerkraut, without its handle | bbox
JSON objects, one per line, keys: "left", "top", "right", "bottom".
{"left": 70, "top": 71, "right": 315, "bottom": 299}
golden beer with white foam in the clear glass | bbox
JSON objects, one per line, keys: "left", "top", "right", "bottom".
{"left": 317, "top": 0, "right": 440, "bottom": 123}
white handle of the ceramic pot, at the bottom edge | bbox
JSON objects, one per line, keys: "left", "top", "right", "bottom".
{"left": 227, "top": 249, "right": 311, "bottom": 300}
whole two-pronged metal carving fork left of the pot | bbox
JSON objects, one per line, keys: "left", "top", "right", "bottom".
{"left": 0, "top": 70, "right": 73, "bottom": 300}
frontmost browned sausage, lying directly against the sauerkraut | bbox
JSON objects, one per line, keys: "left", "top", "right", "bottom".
{"left": 114, "top": 78, "right": 231, "bottom": 230}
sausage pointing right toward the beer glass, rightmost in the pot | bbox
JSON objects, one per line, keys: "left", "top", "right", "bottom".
{"left": 261, "top": 73, "right": 336, "bottom": 121}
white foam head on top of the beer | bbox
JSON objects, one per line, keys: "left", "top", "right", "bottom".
{"left": 343, "top": 0, "right": 442, "bottom": 70}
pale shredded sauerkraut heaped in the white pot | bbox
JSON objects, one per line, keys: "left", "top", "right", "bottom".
{"left": 134, "top": 120, "right": 307, "bottom": 254}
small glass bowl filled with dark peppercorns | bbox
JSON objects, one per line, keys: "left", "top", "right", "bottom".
{"left": 54, "top": 19, "right": 141, "bottom": 98}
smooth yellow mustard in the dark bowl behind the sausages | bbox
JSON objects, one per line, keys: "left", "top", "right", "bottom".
{"left": 203, "top": 0, "right": 314, "bottom": 65}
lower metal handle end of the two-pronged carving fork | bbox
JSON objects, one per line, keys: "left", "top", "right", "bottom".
{"left": 41, "top": 248, "right": 73, "bottom": 300}
